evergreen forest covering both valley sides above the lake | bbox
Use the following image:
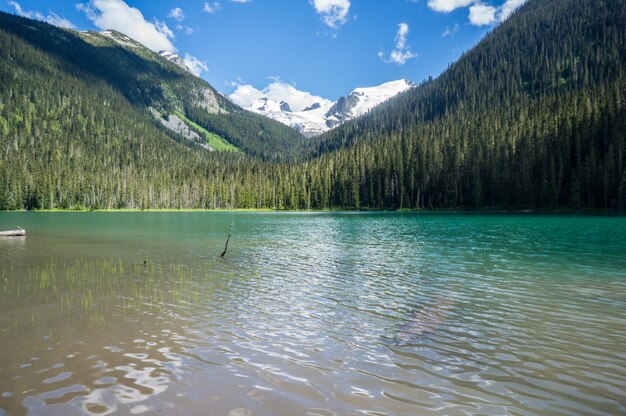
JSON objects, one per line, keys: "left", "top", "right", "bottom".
{"left": 0, "top": 0, "right": 626, "bottom": 209}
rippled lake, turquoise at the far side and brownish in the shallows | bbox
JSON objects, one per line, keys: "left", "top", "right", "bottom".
{"left": 0, "top": 212, "right": 626, "bottom": 416}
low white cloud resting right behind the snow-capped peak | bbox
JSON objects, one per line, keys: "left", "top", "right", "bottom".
{"left": 229, "top": 77, "right": 331, "bottom": 111}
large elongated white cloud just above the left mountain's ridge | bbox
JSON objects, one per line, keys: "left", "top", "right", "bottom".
{"left": 76, "top": 0, "right": 176, "bottom": 52}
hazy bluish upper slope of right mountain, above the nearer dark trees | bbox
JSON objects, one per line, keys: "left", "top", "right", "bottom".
{"left": 320, "top": 0, "right": 626, "bottom": 153}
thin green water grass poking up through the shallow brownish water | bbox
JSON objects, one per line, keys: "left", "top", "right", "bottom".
{"left": 1, "top": 258, "right": 219, "bottom": 329}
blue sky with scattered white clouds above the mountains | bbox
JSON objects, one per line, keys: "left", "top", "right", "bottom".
{"left": 0, "top": 0, "right": 525, "bottom": 100}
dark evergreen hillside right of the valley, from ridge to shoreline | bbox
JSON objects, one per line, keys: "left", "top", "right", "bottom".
{"left": 308, "top": 0, "right": 626, "bottom": 208}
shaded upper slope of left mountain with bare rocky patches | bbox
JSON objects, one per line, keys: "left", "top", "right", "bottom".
{"left": 0, "top": 13, "right": 302, "bottom": 160}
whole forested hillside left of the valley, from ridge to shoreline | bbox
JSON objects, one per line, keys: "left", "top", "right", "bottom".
{"left": 0, "top": 13, "right": 301, "bottom": 209}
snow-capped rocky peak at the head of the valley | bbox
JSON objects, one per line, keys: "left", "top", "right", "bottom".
{"left": 230, "top": 79, "right": 415, "bottom": 137}
